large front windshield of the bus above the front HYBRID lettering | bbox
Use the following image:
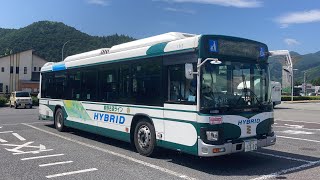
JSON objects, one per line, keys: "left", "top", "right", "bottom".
{"left": 201, "top": 61, "right": 270, "bottom": 110}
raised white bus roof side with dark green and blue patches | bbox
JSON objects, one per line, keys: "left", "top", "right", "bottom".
{"left": 41, "top": 32, "right": 268, "bottom": 72}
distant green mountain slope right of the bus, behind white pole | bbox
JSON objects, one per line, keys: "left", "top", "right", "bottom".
{"left": 269, "top": 51, "right": 320, "bottom": 83}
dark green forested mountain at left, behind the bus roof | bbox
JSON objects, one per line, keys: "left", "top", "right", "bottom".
{"left": 0, "top": 21, "right": 134, "bottom": 62}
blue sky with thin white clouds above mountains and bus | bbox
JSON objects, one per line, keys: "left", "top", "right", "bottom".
{"left": 0, "top": 0, "right": 320, "bottom": 54}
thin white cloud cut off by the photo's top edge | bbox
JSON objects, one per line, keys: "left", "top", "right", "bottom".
{"left": 153, "top": 0, "right": 262, "bottom": 8}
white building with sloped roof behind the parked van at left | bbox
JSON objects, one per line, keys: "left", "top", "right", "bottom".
{"left": 0, "top": 50, "right": 47, "bottom": 94}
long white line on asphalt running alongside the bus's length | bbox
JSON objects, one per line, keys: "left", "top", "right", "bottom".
{"left": 24, "top": 124, "right": 195, "bottom": 180}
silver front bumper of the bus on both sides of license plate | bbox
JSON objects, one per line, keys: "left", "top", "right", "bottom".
{"left": 198, "top": 135, "right": 276, "bottom": 157}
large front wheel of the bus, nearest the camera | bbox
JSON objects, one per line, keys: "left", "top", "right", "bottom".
{"left": 134, "top": 119, "right": 156, "bottom": 156}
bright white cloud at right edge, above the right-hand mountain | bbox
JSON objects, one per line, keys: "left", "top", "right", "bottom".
{"left": 276, "top": 10, "right": 320, "bottom": 28}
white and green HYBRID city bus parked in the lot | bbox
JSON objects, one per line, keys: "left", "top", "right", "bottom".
{"left": 39, "top": 32, "right": 276, "bottom": 156}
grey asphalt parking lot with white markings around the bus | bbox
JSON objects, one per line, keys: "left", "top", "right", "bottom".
{"left": 0, "top": 103, "right": 320, "bottom": 180}
